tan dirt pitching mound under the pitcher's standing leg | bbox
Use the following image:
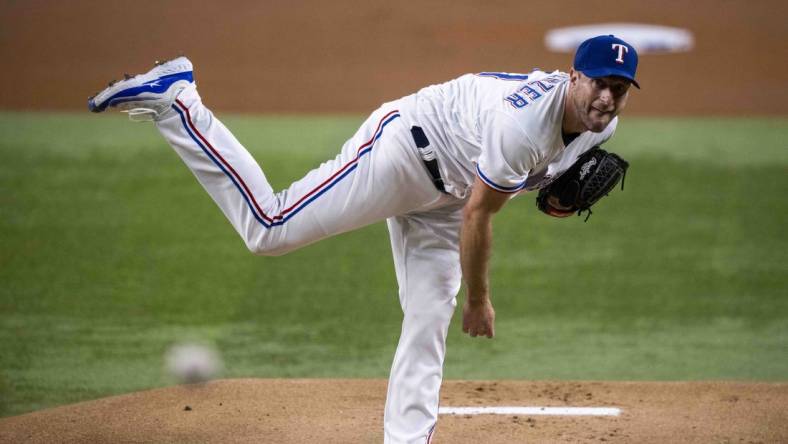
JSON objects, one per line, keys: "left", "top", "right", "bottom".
{"left": 0, "top": 379, "right": 788, "bottom": 444}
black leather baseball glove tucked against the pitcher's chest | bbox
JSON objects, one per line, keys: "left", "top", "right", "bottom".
{"left": 536, "top": 146, "right": 629, "bottom": 221}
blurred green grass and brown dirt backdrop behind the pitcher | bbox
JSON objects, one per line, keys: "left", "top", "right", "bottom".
{"left": 0, "top": 0, "right": 788, "bottom": 416}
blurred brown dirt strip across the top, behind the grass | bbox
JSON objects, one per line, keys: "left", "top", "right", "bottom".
{"left": 0, "top": 0, "right": 788, "bottom": 115}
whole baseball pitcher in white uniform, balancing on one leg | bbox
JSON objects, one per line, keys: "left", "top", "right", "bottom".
{"left": 88, "top": 35, "right": 639, "bottom": 443}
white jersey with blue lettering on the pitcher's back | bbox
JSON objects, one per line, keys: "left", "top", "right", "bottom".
{"left": 401, "top": 71, "right": 618, "bottom": 198}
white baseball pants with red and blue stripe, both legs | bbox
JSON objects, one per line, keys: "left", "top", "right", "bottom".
{"left": 157, "top": 86, "right": 464, "bottom": 443}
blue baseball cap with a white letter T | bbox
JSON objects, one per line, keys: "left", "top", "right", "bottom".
{"left": 575, "top": 34, "right": 640, "bottom": 88}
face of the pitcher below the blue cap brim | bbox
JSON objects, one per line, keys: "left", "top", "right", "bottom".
{"left": 571, "top": 71, "right": 630, "bottom": 133}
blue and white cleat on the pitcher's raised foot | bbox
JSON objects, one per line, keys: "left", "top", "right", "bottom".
{"left": 88, "top": 56, "right": 194, "bottom": 122}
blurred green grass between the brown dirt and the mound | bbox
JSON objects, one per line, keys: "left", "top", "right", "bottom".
{"left": 0, "top": 113, "right": 788, "bottom": 416}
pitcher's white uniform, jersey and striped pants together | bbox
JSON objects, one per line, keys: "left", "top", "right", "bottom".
{"left": 157, "top": 67, "right": 616, "bottom": 443}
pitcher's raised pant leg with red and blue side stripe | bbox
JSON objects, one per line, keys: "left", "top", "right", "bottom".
{"left": 157, "top": 85, "right": 442, "bottom": 255}
